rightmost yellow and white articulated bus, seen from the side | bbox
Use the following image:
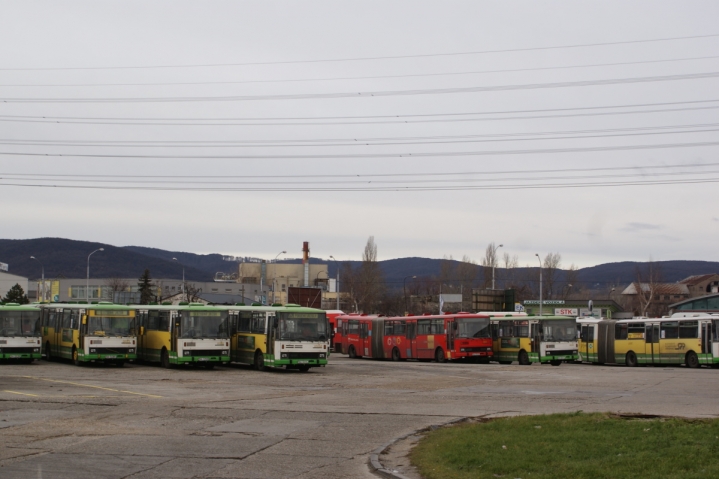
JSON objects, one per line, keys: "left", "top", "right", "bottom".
{"left": 587, "top": 313, "right": 719, "bottom": 368}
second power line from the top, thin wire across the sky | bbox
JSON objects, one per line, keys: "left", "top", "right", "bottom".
{"left": 0, "top": 55, "right": 719, "bottom": 88}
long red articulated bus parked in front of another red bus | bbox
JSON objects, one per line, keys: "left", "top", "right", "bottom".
{"left": 337, "top": 313, "right": 492, "bottom": 362}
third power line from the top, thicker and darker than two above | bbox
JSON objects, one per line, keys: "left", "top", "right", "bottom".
{"left": 0, "top": 72, "right": 719, "bottom": 103}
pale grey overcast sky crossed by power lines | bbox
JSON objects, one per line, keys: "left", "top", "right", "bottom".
{"left": 0, "top": 0, "right": 719, "bottom": 267}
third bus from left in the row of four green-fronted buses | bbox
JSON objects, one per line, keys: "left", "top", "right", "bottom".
{"left": 133, "top": 303, "right": 230, "bottom": 369}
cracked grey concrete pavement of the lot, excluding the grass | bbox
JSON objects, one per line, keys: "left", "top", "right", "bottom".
{"left": 0, "top": 355, "right": 719, "bottom": 479}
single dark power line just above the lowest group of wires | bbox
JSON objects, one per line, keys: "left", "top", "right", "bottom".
{"left": 0, "top": 141, "right": 719, "bottom": 160}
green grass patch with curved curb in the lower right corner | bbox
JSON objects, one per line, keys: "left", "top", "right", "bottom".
{"left": 410, "top": 413, "right": 719, "bottom": 479}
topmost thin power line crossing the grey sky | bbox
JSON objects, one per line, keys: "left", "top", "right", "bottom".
{"left": 0, "top": 33, "right": 719, "bottom": 71}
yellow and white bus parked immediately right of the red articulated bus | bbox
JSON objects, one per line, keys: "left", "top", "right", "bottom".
{"left": 492, "top": 315, "right": 578, "bottom": 366}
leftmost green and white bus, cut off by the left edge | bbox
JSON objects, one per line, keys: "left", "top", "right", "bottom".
{"left": 0, "top": 303, "right": 42, "bottom": 364}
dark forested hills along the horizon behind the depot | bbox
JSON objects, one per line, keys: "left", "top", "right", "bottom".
{"left": 0, "top": 238, "right": 719, "bottom": 288}
